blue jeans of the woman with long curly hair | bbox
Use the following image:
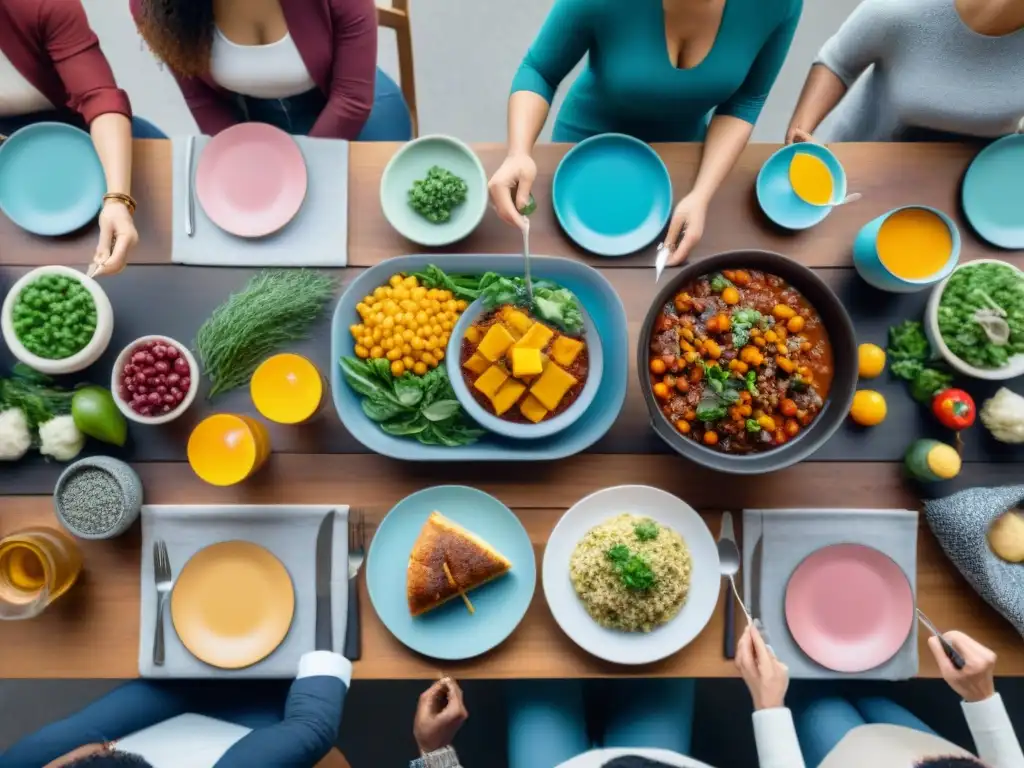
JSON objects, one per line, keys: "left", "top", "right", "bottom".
{"left": 234, "top": 69, "right": 413, "bottom": 141}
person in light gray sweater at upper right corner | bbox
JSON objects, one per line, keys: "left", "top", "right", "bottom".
{"left": 785, "top": 0, "right": 1024, "bottom": 143}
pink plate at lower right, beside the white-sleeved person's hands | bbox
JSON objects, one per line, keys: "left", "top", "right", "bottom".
{"left": 785, "top": 544, "right": 914, "bottom": 672}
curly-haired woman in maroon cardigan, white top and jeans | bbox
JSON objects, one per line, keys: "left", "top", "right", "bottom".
{"left": 130, "top": 0, "right": 412, "bottom": 141}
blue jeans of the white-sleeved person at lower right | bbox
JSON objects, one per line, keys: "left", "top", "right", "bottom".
{"left": 786, "top": 689, "right": 935, "bottom": 768}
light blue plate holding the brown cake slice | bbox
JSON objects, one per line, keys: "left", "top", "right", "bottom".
{"left": 367, "top": 485, "right": 537, "bottom": 659}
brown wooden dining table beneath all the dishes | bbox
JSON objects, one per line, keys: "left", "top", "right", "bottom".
{"left": 0, "top": 140, "right": 1024, "bottom": 679}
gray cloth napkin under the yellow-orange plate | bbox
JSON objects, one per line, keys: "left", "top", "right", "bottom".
{"left": 138, "top": 505, "right": 348, "bottom": 678}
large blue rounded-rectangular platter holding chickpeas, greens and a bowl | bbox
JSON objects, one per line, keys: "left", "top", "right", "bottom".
{"left": 331, "top": 254, "right": 629, "bottom": 462}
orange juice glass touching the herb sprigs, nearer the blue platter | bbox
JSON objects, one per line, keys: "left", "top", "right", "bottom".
{"left": 249, "top": 352, "right": 326, "bottom": 424}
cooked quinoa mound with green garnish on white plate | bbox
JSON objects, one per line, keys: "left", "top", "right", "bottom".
{"left": 569, "top": 514, "right": 691, "bottom": 632}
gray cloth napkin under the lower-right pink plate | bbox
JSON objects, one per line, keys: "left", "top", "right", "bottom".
{"left": 742, "top": 509, "right": 918, "bottom": 680}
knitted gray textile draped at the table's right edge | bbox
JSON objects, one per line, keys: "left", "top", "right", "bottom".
{"left": 925, "top": 485, "right": 1024, "bottom": 636}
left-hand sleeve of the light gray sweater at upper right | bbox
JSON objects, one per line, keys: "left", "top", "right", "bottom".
{"left": 815, "top": 0, "right": 898, "bottom": 87}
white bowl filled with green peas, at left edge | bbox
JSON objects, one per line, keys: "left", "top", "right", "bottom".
{"left": 0, "top": 265, "right": 114, "bottom": 376}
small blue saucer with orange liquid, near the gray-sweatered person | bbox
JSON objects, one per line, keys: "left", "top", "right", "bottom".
{"left": 757, "top": 142, "right": 846, "bottom": 229}
